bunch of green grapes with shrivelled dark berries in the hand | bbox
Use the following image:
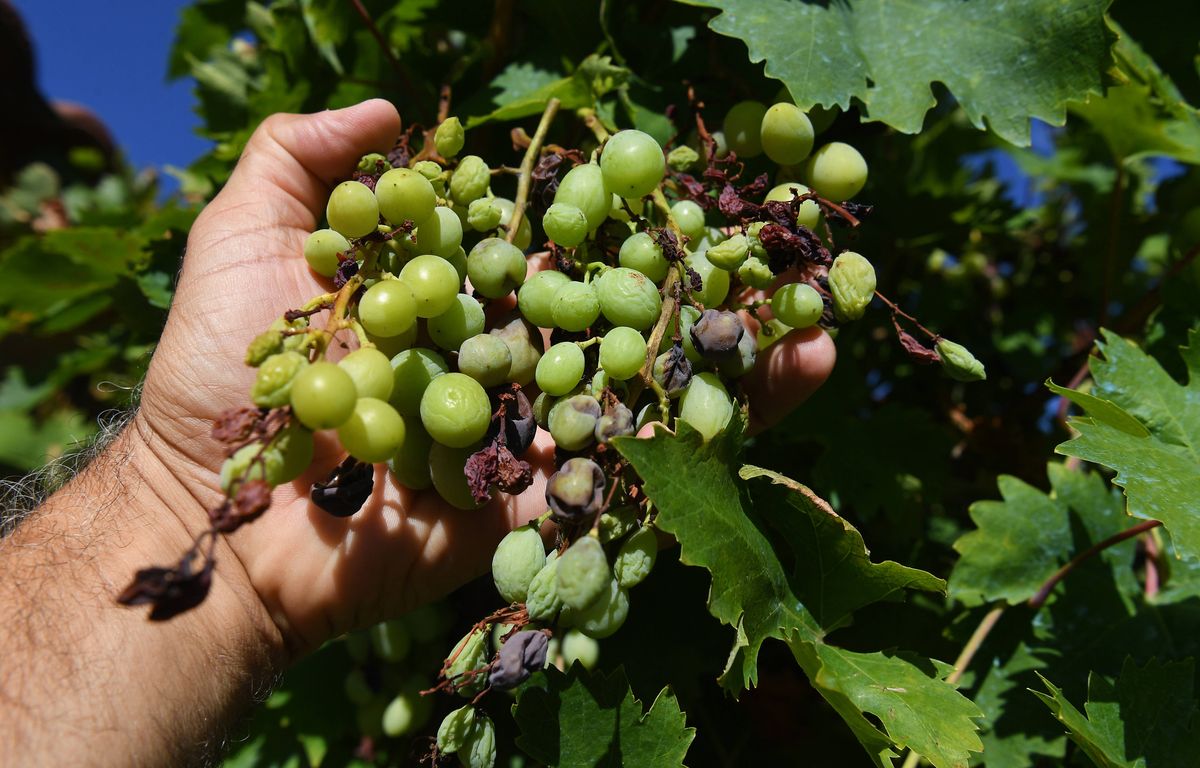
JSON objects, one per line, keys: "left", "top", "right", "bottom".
{"left": 119, "top": 90, "right": 983, "bottom": 767}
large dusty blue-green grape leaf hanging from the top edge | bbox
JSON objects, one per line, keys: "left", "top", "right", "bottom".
{"left": 683, "top": 0, "right": 1115, "bottom": 146}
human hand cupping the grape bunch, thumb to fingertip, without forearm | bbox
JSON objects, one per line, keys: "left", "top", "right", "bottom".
{"left": 131, "top": 101, "right": 834, "bottom": 655}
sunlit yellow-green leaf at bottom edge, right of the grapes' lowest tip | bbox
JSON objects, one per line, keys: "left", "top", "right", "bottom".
{"left": 788, "top": 638, "right": 983, "bottom": 768}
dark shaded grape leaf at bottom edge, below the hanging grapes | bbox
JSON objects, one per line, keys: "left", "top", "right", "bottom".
{"left": 512, "top": 662, "right": 696, "bottom": 768}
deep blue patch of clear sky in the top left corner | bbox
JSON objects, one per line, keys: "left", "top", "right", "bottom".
{"left": 13, "top": 0, "right": 208, "bottom": 188}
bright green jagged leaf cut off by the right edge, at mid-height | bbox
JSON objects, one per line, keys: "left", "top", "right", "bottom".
{"left": 1056, "top": 330, "right": 1200, "bottom": 559}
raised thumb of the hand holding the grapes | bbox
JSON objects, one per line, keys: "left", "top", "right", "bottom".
{"left": 210, "top": 98, "right": 401, "bottom": 230}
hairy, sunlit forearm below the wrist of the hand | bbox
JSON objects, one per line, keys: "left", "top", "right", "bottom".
{"left": 0, "top": 427, "right": 281, "bottom": 764}
